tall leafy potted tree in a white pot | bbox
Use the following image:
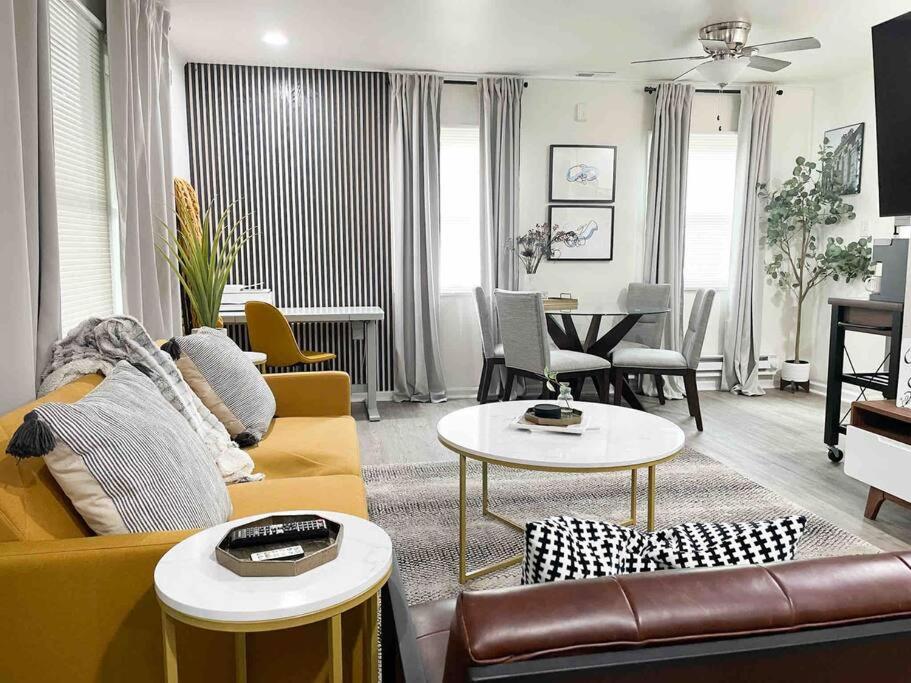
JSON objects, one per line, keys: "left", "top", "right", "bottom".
{"left": 759, "top": 139, "right": 873, "bottom": 383}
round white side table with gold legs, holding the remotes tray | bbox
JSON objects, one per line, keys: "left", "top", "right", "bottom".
{"left": 155, "top": 510, "right": 392, "bottom": 683}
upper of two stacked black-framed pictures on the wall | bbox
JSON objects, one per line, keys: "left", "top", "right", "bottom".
{"left": 548, "top": 145, "right": 617, "bottom": 204}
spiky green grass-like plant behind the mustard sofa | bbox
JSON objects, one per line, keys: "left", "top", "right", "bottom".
{"left": 156, "top": 198, "right": 253, "bottom": 328}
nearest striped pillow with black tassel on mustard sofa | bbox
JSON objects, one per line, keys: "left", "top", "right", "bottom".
{"left": 7, "top": 361, "right": 231, "bottom": 534}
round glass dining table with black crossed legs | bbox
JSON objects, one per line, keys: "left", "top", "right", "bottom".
{"left": 544, "top": 304, "right": 670, "bottom": 410}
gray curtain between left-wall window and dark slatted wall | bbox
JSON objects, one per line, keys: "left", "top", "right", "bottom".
{"left": 107, "top": 0, "right": 180, "bottom": 339}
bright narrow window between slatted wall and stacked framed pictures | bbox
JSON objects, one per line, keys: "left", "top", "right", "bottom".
{"left": 440, "top": 126, "right": 481, "bottom": 291}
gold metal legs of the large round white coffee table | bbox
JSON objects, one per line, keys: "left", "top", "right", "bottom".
{"left": 459, "top": 453, "right": 657, "bottom": 583}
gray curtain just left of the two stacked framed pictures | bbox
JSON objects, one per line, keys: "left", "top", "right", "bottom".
{"left": 478, "top": 76, "right": 525, "bottom": 391}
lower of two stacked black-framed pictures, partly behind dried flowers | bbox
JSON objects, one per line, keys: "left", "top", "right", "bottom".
{"left": 547, "top": 204, "right": 614, "bottom": 261}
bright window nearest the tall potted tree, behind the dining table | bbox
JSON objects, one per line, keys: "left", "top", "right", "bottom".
{"left": 683, "top": 133, "right": 737, "bottom": 289}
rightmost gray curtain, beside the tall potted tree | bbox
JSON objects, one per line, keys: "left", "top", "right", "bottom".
{"left": 721, "top": 84, "right": 775, "bottom": 396}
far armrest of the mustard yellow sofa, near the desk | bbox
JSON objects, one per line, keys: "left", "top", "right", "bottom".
{"left": 265, "top": 371, "right": 351, "bottom": 417}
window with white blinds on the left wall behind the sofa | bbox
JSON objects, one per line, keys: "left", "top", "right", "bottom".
{"left": 48, "top": 0, "right": 120, "bottom": 332}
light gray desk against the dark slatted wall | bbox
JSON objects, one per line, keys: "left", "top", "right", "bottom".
{"left": 221, "top": 306, "right": 386, "bottom": 422}
